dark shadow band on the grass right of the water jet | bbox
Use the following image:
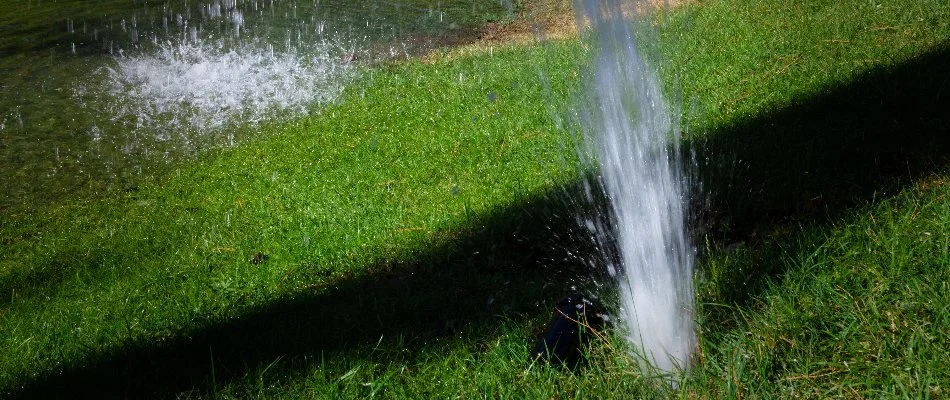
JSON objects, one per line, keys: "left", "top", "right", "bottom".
{"left": 687, "top": 43, "right": 950, "bottom": 306}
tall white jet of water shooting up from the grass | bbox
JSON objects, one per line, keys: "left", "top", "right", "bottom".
{"left": 576, "top": 0, "right": 696, "bottom": 374}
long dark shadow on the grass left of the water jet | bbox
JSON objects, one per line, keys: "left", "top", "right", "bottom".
{"left": 7, "top": 184, "right": 589, "bottom": 398}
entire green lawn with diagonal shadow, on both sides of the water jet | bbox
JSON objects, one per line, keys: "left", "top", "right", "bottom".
{"left": 0, "top": 0, "right": 950, "bottom": 398}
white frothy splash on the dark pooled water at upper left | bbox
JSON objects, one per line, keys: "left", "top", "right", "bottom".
{"left": 107, "top": 40, "right": 351, "bottom": 135}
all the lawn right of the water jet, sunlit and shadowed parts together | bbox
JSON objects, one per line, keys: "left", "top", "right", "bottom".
{"left": 664, "top": 1, "right": 950, "bottom": 398}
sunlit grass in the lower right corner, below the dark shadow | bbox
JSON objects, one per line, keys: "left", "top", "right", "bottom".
{"left": 691, "top": 177, "right": 950, "bottom": 398}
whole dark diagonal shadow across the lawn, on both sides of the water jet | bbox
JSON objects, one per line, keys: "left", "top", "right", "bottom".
{"left": 9, "top": 42, "right": 950, "bottom": 398}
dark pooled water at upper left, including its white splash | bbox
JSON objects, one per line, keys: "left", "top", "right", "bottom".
{"left": 0, "top": 0, "right": 511, "bottom": 215}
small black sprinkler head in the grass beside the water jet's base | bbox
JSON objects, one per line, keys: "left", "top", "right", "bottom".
{"left": 531, "top": 293, "right": 604, "bottom": 368}
